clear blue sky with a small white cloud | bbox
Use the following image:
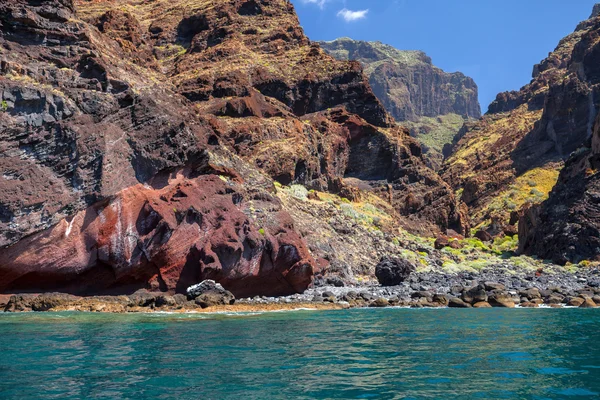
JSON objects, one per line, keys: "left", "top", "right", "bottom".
{"left": 292, "top": 0, "right": 600, "bottom": 112}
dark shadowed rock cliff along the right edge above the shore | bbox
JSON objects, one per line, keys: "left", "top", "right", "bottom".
{"left": 519, "top": 9, "right": 600, "bottom": 263}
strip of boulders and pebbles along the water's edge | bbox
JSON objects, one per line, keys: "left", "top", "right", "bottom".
{"left": 0, "top": 268, "right": 600, "bottom": 313}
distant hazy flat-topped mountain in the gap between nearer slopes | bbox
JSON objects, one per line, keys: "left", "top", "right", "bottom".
{"left": 319, "top": 38, "right": 481, "bottom": 169}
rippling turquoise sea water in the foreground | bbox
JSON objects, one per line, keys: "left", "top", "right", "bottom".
{"left": 0, "top": 309, "right": 600, "bottom": 400}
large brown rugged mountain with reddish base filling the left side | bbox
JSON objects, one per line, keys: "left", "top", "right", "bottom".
{"left": 0, "top": 0, "right": 466, "bottom": 296}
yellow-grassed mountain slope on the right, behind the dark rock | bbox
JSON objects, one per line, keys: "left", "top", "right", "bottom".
{"left": 442, "top": 6, "right": 600, "bottom": 245}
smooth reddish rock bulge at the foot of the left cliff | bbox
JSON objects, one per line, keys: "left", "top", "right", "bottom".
{"left": 0, "top": 175, "right": 314, "bottom": 296}
